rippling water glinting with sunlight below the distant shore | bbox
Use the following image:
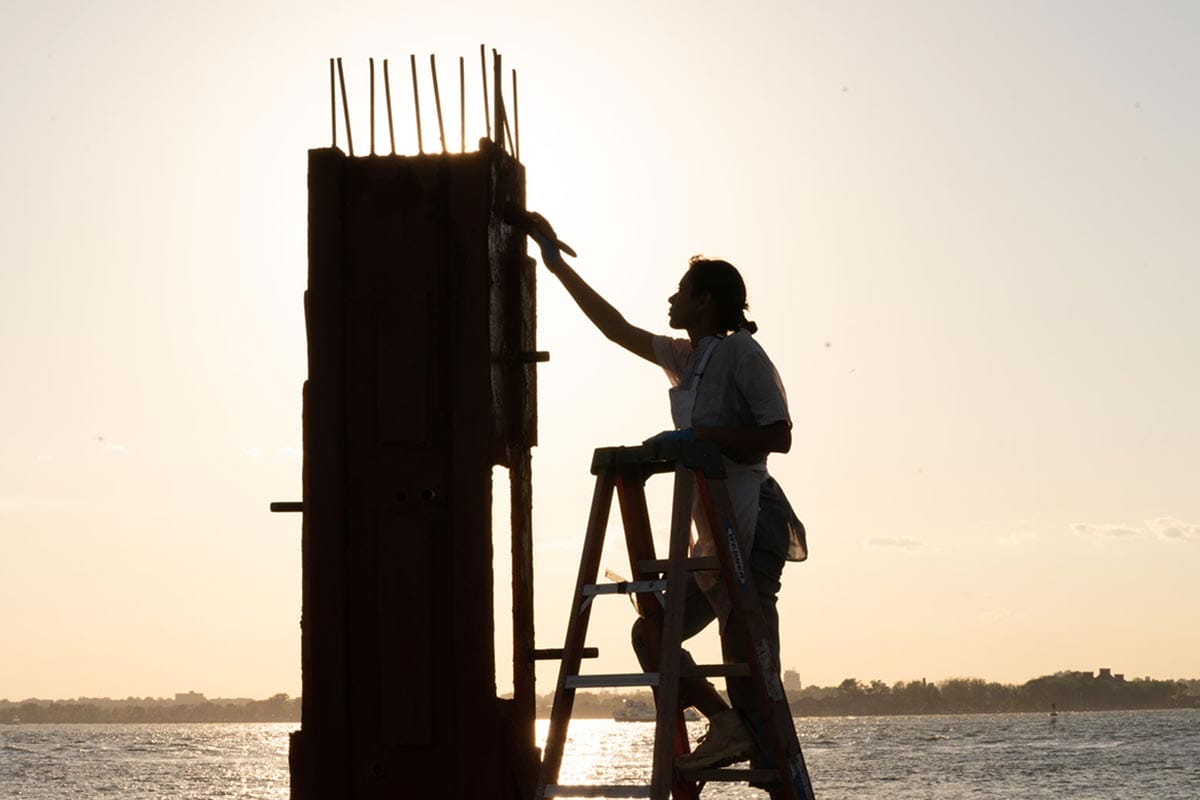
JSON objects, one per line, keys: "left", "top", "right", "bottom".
{"left": 0, "top": 710, "right": 1200, "bottom": 800}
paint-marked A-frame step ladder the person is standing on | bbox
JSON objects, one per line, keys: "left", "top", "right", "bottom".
{"left": 535, "top": 441, "right": 814, "bottom": 800}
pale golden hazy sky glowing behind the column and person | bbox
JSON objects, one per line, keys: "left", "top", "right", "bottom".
{"left": 0, "top": 0, "right": 1200, "bottom": 699}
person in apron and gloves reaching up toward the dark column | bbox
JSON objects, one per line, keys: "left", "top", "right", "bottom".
{"left": 532, "top": 215, "right": 806, "bottom": 791}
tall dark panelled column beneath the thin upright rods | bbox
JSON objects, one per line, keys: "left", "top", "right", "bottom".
{"left": 290, "top": 139, "right": 538, "bottom": 800}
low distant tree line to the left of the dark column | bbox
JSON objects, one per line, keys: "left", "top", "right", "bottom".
{"left": 0, "top": 693, "right": 300, "bottom": 724}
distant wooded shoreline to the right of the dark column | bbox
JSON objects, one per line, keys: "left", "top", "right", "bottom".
{"left": 538, "top": 672, "right": 1200, "bottom": 718}
